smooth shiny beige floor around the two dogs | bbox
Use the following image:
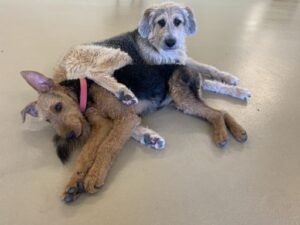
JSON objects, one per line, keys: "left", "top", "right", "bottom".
{"left": 0, "top": 0, "right": 300, "bottom": 225}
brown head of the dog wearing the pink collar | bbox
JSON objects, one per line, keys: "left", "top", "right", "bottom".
{"left": 21, "top": 71, "right": 89, "bottom": 161}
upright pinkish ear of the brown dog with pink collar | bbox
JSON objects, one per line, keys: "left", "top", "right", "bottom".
{"left": 20, "top": 71, "right": 54, "bottom": 93}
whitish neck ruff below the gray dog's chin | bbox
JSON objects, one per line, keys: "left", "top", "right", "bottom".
{"left": 137, "top": 35, "right": 187, "bottom": 65}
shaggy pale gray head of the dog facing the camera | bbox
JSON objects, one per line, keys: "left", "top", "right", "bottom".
{"left": 138, "top": 2, "right": 196, "bottom": 50}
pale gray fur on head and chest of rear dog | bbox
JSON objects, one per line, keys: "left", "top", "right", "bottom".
{"left": 138, "top": 2, "right": 196, "bottom": 64}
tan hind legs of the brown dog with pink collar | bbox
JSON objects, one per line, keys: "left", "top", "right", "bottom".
{"left": 169, "top": 71, "right": 247, "bottom": 147}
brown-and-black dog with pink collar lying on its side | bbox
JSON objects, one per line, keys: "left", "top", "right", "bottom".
{"left": 21, "top": 62, "right": 247, "bottom": 203}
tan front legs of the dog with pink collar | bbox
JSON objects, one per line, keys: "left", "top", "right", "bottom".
{"left": 63, "top": 85, "right": 140, "bottom": 200}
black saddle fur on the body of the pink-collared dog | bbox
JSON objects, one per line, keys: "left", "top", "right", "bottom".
{"left": 114, "top": 64, "right": 201, "bottom": 105}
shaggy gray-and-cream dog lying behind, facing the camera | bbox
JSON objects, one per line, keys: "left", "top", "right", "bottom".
{"left": 55, "top": 2, "right": 251, "bottom": 105}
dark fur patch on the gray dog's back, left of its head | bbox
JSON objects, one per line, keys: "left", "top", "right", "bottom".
{"left": 93, "top": 30, "right": 145, "bottom": 64}
